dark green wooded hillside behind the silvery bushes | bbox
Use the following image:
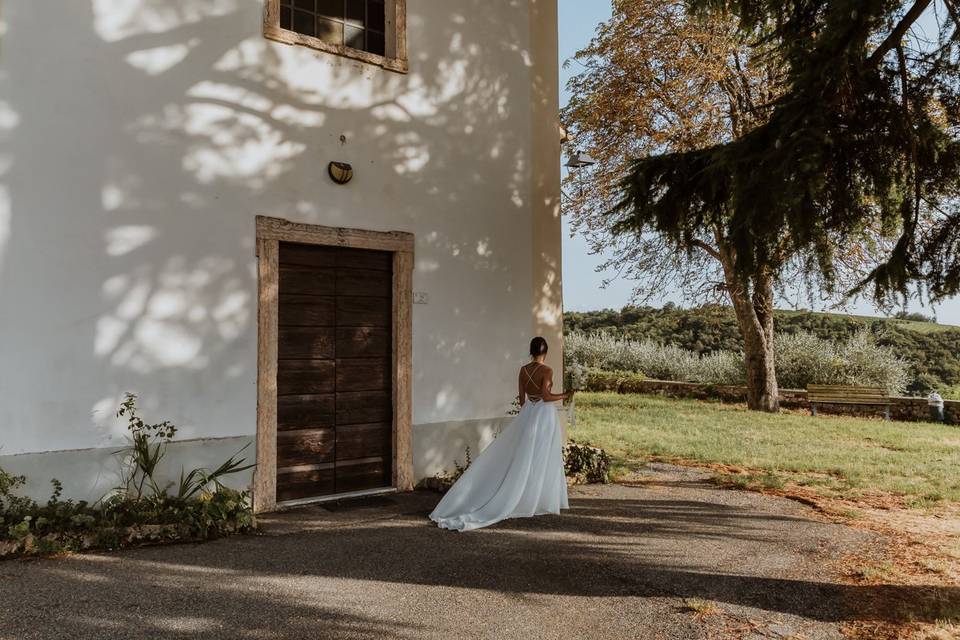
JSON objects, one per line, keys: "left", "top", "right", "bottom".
{"left": 564, "top": 304, "right": 960, "bottom": 396}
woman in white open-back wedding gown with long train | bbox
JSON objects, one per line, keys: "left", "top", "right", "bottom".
{"left": 430, "top": 337, "right": 574, "bottom": 531}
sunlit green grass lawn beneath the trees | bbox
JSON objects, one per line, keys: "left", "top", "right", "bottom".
{"left": 568, "top": 393, "right": 960, "bottom": 506}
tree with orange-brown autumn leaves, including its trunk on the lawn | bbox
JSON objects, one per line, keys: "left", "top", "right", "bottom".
{"left": 563, "top": 0, "right": 896, "bottom": 410}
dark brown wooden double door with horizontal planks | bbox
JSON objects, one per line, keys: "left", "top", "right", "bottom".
{"left": 277, "top": 242, "right": 394, "bottom": 502}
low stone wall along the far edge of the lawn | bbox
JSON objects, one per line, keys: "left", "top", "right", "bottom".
{"left": 604, "top": 380, "right": 960, "bottom": 425}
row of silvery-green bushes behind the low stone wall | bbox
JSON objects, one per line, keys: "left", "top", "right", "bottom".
{"left": 565, "top": 331, "right": 910, "bottom": 393}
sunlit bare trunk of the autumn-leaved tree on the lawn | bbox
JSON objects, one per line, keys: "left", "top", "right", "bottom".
{"left": 719, "top": 245, "right": 780, "bottom": 413}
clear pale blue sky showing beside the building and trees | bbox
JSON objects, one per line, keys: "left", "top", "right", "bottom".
{"left": 558, "top": 0, "right": 960, "bottom": 325}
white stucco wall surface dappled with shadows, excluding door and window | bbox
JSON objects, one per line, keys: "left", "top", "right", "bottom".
{"left": 0, "top": 0, "right": 559, "bottom": 492}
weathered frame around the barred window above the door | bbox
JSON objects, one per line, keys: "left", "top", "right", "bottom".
{"left": 263, "top": 0, "right": 409, "bottom": 73}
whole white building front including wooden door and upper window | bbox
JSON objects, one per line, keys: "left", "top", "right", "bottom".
{"left": 0, "top": 0, "right": 562, "bottom": 510}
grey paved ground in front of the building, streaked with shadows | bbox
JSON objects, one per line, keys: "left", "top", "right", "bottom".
{"left": 0, "top": 465, "right": 870, "bottom": 640}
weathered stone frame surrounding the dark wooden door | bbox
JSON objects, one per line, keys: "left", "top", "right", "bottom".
{"left": 253, "top": 216, "right": 414, "bottom": 513}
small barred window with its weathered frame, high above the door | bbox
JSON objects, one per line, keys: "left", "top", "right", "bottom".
{"left": 264, "top": 0, "right": 407, "bottom": 72}
